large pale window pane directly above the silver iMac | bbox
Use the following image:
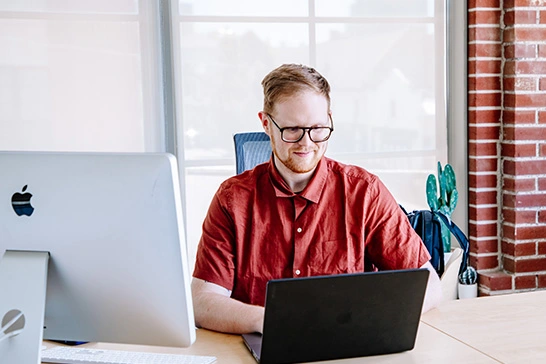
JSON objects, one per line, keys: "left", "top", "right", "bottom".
{"left": 0, "top": 19, "right": 152, "bottom": 151}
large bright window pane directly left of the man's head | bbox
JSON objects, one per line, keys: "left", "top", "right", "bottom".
{"left": 180, "top": 23, "right": 309, "bottom": 160}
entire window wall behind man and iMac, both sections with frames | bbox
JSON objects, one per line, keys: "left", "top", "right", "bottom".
{"left": 0, "top": 0, "right": 466, "bottom": 268}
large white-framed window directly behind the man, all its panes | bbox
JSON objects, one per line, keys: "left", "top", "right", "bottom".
{"left": 169, "top": 0, "right": 447, "bottom": 268}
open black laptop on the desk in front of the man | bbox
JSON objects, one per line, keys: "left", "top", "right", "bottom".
{"left": 243, "top": 269, "right": 429, "bottom": 364}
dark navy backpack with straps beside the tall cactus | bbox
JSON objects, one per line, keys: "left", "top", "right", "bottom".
{"left": 401, "top": 206, "right": 469, "bottom": 277}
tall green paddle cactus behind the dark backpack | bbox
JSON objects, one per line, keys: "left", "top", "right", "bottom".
{"left": 427, "top": 162, "right": 459, "bottom": 252}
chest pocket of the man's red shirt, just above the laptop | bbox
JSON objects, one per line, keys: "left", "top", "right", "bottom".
{"left": 309, "top": 239, "right": 363, "bottom": 276}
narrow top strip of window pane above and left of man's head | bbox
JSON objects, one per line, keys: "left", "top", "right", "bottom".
{"left": 179, "top": 0, "right": 308, "bottom": 16}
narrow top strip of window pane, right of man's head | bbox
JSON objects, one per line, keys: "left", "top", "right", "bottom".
{"left": 315, "top": 0, "right": 437, "bottom": 17}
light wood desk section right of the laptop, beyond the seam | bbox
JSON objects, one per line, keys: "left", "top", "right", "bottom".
{"left": 421, "top": 291, "right": 546, "bottom": 364}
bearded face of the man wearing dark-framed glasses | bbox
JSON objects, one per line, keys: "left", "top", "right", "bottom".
{"left": 260, "top": 91, "right": 332, "bottom": 173}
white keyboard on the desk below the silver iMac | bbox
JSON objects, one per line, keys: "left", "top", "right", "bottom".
{"left": 41, "top": 346, "right": 216, "bottom": 364}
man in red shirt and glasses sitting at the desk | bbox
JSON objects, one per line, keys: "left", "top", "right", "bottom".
{"left": 192, "top": 64, "right": 441, "bottom": 333}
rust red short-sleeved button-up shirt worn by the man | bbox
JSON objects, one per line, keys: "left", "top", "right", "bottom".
{"left": 193, "top": 157, "right": 430, "bottom": 306}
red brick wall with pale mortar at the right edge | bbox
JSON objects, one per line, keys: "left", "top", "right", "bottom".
{"left": 468, "top": 0, "right": 546, "bottom": 295}
